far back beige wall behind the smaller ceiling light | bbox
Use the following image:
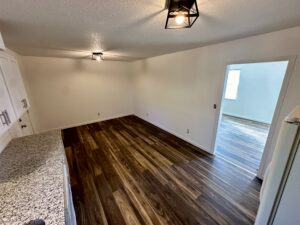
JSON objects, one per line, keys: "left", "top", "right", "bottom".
{"left": 22, "top": 57, "right": 133, "bottom": 132}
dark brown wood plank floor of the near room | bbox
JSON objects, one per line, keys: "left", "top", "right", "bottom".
{"left": 63, "top": 116, "right": 260, "bottom": 225}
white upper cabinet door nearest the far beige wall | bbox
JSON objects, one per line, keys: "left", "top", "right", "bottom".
{"left": 4, "top": 58, "right": 29, "bottom": 118}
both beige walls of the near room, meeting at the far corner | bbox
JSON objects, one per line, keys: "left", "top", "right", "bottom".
{"left": 10, "top": 27, "right": 300, "bottom": 177}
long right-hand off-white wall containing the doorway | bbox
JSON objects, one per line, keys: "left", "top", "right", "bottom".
{"left": 133, "top": 27, "right": 300, "bottom": 177}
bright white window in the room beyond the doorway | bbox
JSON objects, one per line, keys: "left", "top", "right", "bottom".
{"left": 225, "top": 70, "right": 241, "bottom": 100}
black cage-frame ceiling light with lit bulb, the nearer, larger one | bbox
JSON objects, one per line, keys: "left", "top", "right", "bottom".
{"left": 165, "top": 0, "right": 199, "bottom": 29}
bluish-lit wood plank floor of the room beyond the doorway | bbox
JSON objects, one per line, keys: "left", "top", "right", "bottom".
{"left": 216, "top": 115, "right": 270, "bottom": 174}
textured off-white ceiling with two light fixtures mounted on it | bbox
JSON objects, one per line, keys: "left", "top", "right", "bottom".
{"left": 0, "top": 0, "right": 300, "bottom": 60}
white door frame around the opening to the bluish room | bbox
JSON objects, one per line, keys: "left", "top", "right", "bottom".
{"left": 212, "top": 55, "right": 297, "bottom": 179}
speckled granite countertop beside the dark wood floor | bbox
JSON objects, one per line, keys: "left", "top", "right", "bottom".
{"left": 0, "top": 131, "right": 65, "bottom": 225}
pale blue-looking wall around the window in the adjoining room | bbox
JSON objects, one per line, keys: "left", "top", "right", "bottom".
{"left": 222, "top": 61, "right": 288, "bottom": 124}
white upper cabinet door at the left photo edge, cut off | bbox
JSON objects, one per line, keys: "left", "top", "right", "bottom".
{"left": 0, "top": 57, "right": 16, "bottom": 136}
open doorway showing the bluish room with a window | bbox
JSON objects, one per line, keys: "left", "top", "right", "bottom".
{"left": 215, "top": 61, "right": 289, "bottom": 175}
